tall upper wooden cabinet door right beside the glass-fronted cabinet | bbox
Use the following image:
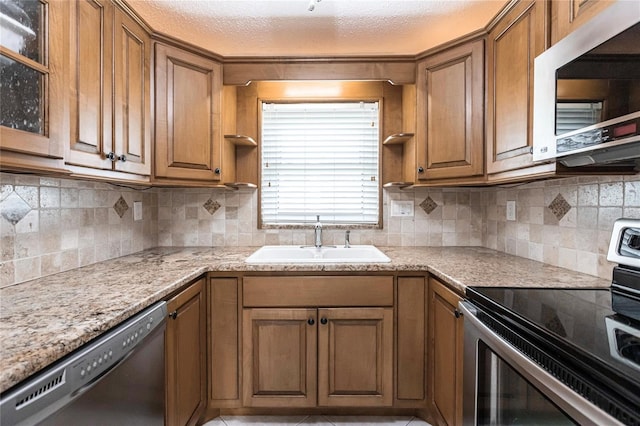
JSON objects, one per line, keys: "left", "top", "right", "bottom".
{"left": 65, "top": 0, "right": 114, "bottom": 170}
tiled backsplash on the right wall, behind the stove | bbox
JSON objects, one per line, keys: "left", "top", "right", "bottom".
{"left": 483, "top": 175, "right": 640, "bottom": 279}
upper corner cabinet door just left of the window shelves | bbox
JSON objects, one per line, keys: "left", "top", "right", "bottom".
{"left": 155, "top": 44, "right": 222, "bottom": 181}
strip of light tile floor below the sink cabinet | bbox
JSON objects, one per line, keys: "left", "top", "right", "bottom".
{"left": 203, "top": 415, "right": 430, "bottom": 426}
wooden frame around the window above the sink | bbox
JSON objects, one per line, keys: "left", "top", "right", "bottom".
{"left": 257, "top": 96, "right": 384, "bottom": 229}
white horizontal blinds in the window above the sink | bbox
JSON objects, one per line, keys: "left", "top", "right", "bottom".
{"left": 261, "top": 102, "right": 380, "bottom": 225}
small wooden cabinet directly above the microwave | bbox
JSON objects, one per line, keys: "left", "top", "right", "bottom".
{"left": 551, "top": 0, "right": 615, "bottom": 44}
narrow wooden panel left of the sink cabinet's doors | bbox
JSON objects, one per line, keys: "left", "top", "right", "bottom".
{"left": 209, "top": 278, "right": 242, "bottom": 408}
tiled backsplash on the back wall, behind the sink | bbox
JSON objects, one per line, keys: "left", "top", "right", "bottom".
{"left": 158, "top": 188, "right": 483, "bottom": 246}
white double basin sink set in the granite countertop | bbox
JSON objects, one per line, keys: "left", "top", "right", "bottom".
{"left": 245, "top": 245, "right": 391, "bottom": 264}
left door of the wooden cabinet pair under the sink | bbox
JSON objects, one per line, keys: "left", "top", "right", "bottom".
{"left": 243, "top": 309, "right": 317, "bottom": 407}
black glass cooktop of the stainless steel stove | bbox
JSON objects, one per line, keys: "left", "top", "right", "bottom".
{"left": 467, "top": 287, "right": 640, "bottom": 420}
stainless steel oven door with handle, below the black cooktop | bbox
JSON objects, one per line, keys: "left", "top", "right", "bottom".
{"left": 459, "top": 301, "right": 621, "bottom": 425}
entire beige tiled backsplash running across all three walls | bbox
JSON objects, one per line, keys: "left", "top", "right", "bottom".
{"left": 0, "top": 173, "right": 640, "bottom": 286}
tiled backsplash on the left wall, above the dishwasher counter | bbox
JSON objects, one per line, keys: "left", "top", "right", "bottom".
{"left": 0, "top": 173, "right": 158, "bottom": 286}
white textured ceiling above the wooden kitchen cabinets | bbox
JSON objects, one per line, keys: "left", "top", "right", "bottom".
{"left": 128, "top": 0, "right": 507, "bottom": 57}
